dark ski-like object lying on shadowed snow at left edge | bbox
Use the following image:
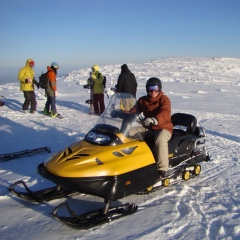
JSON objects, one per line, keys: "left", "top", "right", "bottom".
{"left": 0, "top": 147, "right": 51, "bottom": 162}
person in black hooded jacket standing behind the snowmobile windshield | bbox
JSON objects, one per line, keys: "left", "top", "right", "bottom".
{"left": 115, "top": 64, "right": 138, "bottom": 110}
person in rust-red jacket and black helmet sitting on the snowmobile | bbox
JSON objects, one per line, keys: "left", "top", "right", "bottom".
{"left": 131, "top": 77, "right": 173, "bottom": 178}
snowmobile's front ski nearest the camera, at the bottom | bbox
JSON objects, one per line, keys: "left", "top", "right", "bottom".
{"left": 52, "top": 203, "right": 138, "bottom": 229}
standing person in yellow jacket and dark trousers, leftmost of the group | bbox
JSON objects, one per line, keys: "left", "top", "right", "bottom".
{"left": 18, "top": 59, "right": 39, "bottom": 114}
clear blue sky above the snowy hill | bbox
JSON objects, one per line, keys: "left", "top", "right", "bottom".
{"left": 0, "top": 0, "right": 240, "bottom": 77}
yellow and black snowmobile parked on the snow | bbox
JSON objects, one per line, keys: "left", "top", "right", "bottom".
{"left": 9, "top": 93, "right": 209, "bottom": 229}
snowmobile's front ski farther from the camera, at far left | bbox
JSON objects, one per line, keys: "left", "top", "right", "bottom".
{"left": 8, "top": 181, "right": 75, "bottom": 203}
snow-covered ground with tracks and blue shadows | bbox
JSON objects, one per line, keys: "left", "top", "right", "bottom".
{"left": 0, "top": 58, "right": 240, "bottom": 240}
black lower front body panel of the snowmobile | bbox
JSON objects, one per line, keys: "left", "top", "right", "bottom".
{"left": 38, "top": 163, "right": 159, "bottom": 201}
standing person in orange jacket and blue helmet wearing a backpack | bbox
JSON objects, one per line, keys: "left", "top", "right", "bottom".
{"left": 44, "top": 62, "right": 59, "bottom": 118}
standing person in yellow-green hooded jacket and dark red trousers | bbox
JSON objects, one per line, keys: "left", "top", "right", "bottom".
{"left": 87, "top": 65, "right": 105, "bottom": 115}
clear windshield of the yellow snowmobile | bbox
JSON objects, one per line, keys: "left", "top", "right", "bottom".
{"left": 96, "top": 93, "right": 145, "bottom": 140}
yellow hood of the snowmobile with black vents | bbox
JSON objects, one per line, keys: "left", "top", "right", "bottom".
{"left": 44, "top": 140, "right": 155, "bottom": 178}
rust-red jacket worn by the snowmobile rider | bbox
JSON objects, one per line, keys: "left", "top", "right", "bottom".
{"left": 137, "top": 91, "right": 173, "bottom": 134}
